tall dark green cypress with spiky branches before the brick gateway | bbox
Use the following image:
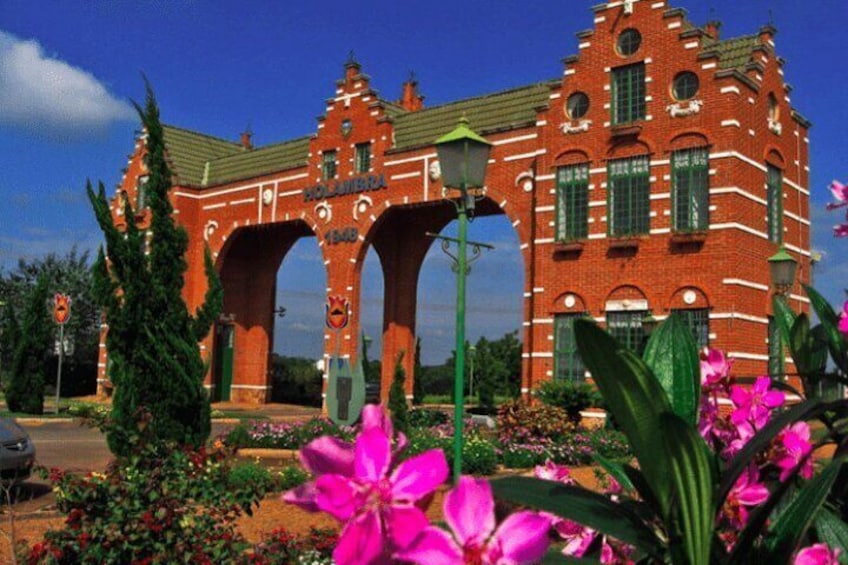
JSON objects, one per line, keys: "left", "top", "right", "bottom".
{"left": 87, "top": 84, "right": 223, "bottom": 456}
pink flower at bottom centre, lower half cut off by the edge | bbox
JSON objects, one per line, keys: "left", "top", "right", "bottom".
{"left": 395, "top": 477, "right": 551, "bottom": 565}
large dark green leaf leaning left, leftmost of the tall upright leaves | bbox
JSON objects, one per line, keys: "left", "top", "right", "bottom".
{"left": 574, "top": 320, "right": 671, "bottom": 516}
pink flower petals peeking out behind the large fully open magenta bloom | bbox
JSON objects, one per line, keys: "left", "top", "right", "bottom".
{"left": 283, "top": 404, "right": 407, "bottom": 512}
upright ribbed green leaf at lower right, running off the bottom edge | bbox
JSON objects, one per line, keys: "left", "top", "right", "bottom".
{"left": 662, "top": 414, "right": 715, "bottom": 565}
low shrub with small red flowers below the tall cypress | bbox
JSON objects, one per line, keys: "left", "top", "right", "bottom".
{"left": 21, "top": 415, "right": 269, "bottom": 565}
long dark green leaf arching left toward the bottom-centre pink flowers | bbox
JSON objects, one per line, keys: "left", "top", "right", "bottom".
{"left": 491, "top": 477, "right": 662, "bottom": 555}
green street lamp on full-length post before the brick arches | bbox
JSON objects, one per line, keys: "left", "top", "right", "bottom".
{"left": 434, "top": 116, "right": 492, "bottom": 484}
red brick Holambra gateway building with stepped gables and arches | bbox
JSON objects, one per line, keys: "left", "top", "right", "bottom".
{"left": 100, "top": 0, "right": 811, "bottom": 402}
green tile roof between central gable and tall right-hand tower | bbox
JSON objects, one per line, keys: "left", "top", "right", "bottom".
{"left": 394, "top": 80, "right": 559, "bottom": 151}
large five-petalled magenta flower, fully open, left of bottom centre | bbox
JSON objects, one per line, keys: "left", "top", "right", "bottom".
{"left": 314, "top": 427, "right": 448, "bottom": 565}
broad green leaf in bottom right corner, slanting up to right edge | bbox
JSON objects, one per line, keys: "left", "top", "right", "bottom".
{"left": 767, "top": 459, "right": 844, "bottom": 558}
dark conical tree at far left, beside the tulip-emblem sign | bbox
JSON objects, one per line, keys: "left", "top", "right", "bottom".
{"left": 5, "top": 276, "right": 53, "bottom": 414}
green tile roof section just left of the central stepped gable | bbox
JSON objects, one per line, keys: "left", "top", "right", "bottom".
{"left": 203, "top": 137, "right": 309, "bottom": 186}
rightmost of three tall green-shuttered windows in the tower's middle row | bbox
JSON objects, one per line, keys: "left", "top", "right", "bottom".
{"left": 671, "top": 147, "right": 710, "bottom": 232}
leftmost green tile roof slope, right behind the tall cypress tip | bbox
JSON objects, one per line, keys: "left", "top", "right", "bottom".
{"left": 162, "top": 124, "right": 244, "bottom": 186}
